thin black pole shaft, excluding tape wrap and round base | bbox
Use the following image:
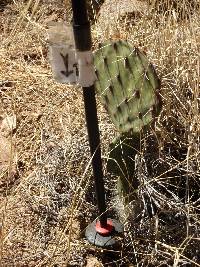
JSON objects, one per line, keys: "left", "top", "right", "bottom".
{"left": 72, "top": 0, "right": 107, "bottom": 227}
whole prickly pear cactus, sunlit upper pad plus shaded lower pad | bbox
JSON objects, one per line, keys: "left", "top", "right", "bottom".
{"left": 94, "top": 40, "right": 161, "bottom": 203}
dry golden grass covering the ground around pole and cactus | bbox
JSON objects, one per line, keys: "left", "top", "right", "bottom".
{"left": 0, "top": 0, "right": 200, "bottom": 267}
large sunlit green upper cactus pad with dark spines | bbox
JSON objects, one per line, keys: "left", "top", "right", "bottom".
{"left": 94, "top": 41, "right": 161, "bottom": 133}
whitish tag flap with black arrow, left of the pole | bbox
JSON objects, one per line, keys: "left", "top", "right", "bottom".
{"left": 48, "top": 22, "right": 78, "bottom": 84}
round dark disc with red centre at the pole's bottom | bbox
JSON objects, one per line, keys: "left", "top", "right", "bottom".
{"left": 85, "top": 219, "right": 124, "bottom": 247}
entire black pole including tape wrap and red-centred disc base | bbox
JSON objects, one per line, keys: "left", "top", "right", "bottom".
{"left": 71, "top": 0, "right": 123, "bottom": 246}
